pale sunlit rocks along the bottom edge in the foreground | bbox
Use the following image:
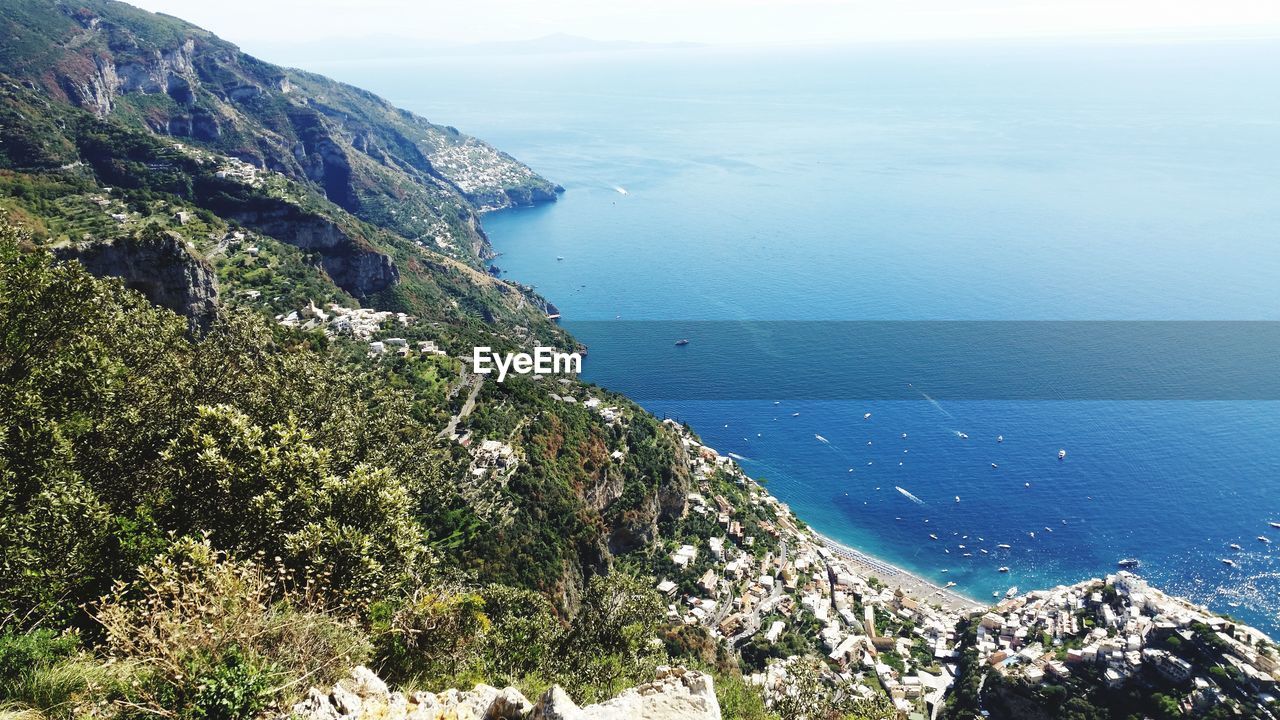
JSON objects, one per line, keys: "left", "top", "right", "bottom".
{"left": 291, "top": 667, "right": 721, "bottom": 720}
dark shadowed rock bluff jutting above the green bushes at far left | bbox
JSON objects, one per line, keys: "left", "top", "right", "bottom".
{"left": 56, "top": 232, "right": 218, "bottom": 328}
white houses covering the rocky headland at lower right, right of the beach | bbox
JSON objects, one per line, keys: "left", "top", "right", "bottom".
{"left": 977, "top": 571, "right": 1280, "bottom": 712}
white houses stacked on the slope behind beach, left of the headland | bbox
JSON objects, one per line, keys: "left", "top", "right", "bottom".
{"left": 658, "top": 420, "right": 975, "bottom": 717}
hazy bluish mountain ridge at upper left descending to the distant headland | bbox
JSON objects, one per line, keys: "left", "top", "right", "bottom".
{"left": 0, "top": 0, "right": 559, "bottom": 261}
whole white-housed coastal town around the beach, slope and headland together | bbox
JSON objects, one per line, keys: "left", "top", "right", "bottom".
{"left": 657, "top": 419, "right": 1280, "bottom": 720}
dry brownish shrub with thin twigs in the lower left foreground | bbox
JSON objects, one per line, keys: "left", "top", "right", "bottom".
{"left": 96, "top": 539, "right": 369, "bottom": 719}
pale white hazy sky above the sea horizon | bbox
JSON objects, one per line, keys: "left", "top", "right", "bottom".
{"left": 129, "top": 0, "right": 1280, "bottom": 50}
